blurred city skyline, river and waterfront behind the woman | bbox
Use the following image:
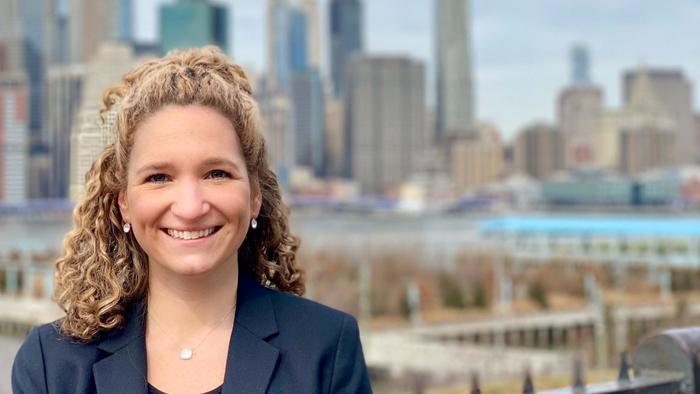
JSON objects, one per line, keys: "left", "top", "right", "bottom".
{"left": 0, "top": 0, "right": 700, "bottom": 393}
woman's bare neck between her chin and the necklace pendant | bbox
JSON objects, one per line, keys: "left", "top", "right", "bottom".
{"left": 147, "top": 262, "right": 238, "bottom": 338}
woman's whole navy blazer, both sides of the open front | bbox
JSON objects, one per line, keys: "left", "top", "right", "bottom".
{"left": 12, "top": 273, "right": 372, "bottom": 394}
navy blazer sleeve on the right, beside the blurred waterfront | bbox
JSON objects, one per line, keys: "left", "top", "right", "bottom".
{"left": 330, "top": 315, "right": 372, "bottom": 394}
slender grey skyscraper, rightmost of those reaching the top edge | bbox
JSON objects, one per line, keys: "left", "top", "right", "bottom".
{"left": 435, "top": 0, "right": 476, "bottom": 140}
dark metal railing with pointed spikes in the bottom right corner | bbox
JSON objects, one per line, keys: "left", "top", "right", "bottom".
{"left": 504, "top": 327, "right": 700, "bottom": 394}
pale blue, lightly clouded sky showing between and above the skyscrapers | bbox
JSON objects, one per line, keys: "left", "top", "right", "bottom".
{"left": 136, "top": 0, "right": 700, "bottom": 139}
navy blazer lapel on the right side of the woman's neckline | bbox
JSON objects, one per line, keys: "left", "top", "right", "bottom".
{"left": 222, "top": 272, "right": 279, "bottom": 394}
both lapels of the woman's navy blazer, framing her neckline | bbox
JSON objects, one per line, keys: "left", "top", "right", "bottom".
{"left": 92, "top": 272, "right": 279, "bottom": 394}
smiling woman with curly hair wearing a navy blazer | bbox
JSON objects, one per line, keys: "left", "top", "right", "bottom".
{"left": 12, "top": 47, "right": 371, "bottom": 394}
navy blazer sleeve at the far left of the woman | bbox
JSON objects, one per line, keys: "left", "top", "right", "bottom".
{"left": 12, "top": 327, "right": 47, "bottom": 394}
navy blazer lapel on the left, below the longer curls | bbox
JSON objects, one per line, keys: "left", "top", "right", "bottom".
{"left": 92, "top": 304, "right": 147, "bottom": 394}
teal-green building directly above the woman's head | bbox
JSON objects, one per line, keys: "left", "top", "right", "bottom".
{"left": 160, "top": 0, "right": 229, "bottom": 53}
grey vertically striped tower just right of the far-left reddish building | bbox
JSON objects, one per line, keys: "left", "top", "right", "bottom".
{"left": 44, "top": 64, "right": 84, "bottom": 198}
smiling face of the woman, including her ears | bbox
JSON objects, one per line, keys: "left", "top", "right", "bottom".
{"left": 119, "top": 105, "right": 261, "bottom": 275}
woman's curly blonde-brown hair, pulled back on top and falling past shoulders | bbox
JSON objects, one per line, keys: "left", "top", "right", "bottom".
{"left": 54, "top": 47, "right": 304, "bottom": 342}
